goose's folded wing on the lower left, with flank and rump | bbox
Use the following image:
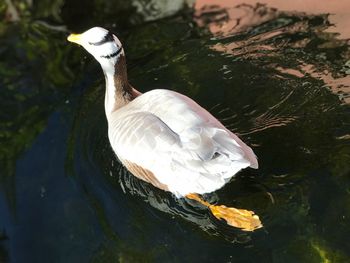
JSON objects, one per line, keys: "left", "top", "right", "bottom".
{"left": 109, "top": 111, "right": 250, "bottom": 196}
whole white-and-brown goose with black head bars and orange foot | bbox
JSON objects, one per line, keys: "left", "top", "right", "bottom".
{"left": 67, "top": 27, "right": 262, "bottom": 231}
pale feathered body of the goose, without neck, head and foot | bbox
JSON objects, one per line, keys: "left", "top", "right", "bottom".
{"left": 108, "top": 89, "right": 257, "bottom": 196}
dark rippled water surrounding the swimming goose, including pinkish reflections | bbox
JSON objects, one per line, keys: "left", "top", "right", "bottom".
{"left": 0, "top": 0, "right": 350, "bottom": 262}
